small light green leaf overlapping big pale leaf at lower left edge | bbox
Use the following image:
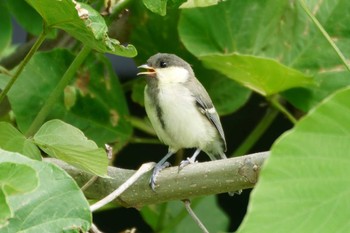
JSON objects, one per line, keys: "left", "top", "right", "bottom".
{"left": 0, "top": 162, "right": 39, "bottom": 228}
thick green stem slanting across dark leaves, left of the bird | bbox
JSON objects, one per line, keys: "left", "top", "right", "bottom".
{"left": 26, "top": 46, "right": 91, "bottom": 137}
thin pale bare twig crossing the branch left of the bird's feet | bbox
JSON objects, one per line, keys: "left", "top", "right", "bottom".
{"left": 90, "top": 163, "right": 154, "bottom": 212}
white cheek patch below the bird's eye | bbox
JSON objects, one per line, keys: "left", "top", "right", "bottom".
{"left": 156, "top": 67, "right": 189, "bottom": 84}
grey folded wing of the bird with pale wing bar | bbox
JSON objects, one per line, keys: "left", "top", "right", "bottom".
{"left": 189, "top": 79, "right": 227, "bottom": 151}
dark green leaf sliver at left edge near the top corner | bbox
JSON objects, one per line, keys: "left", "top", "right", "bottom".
{"left": 0, "top": 1, "right": 12, "bottom": 57}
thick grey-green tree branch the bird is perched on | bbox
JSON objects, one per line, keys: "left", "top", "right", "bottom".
{"left": 45, "top": 152, "right": 269, "bottom": 208}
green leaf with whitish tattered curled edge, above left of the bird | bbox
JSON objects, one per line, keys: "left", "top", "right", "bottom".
{"left": 27, "top": 0, "right": 137, "bottom": 57}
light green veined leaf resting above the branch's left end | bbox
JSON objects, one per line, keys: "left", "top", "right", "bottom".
{"left": 33, "top": 120, "right": 108, "bottom": 176}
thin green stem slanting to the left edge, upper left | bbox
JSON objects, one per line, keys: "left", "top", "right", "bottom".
{"left": 0, "top": 29, "right": 47, "bottom": 103}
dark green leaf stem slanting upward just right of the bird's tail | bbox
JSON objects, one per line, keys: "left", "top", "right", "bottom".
{"left": 232, "top": 108, "right": 279, "bottom": 156}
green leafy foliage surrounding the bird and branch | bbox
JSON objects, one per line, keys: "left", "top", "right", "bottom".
{"left": 0, "top": 0, "right": 350, "bottom": 232}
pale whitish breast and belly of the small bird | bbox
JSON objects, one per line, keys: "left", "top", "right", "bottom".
{"left": 145, "top": 81, "right": 217, "bottom": 151}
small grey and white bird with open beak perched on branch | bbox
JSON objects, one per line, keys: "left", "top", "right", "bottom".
{"left": 137, "top": 53, "right": 226, "bottom": 190}
